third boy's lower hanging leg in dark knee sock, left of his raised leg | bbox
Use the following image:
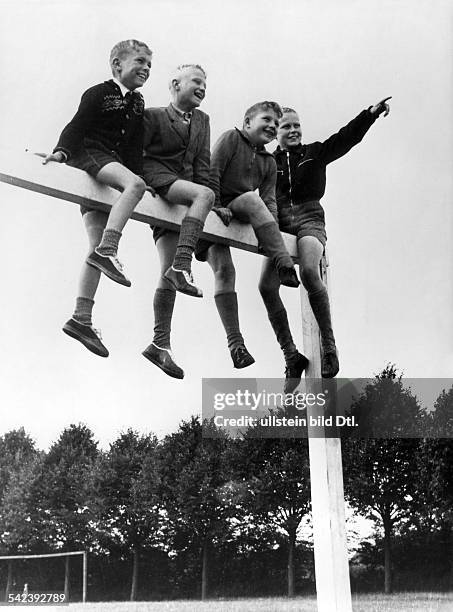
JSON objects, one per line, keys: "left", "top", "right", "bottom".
{"left": 206, "top": 244, "right": 255, "bottom": 369}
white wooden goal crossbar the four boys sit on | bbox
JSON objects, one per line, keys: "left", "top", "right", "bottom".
{"left": 0, "top": 151, "right": 297, "bottom": 259}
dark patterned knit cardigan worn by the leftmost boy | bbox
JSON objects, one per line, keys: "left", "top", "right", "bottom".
{"left": 54, "top": 80, "right": 145, "bottom": 174}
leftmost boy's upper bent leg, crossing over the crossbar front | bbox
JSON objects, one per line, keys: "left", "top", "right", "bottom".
{"left": 87, "top": 162, "right": 145, "bottom": 287}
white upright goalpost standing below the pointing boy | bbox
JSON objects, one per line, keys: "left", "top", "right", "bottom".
{"left": 301, "top": 259, "right": 352, "bottom": 612}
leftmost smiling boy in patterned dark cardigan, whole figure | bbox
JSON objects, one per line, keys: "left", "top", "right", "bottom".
{"left": 43, "top": 39, "right": 152, "bottom": 357}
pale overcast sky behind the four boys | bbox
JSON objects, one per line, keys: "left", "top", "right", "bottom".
{"left": 0, "top": 0, "right": 453, "bottom": 448}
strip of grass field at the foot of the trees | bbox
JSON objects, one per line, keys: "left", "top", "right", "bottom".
{"left": 44, "top": 593, "right": 453, "bottom": 612}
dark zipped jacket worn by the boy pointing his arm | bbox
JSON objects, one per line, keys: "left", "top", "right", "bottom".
{"left": 274, "top": 110, "right": 377, "bottom": 215}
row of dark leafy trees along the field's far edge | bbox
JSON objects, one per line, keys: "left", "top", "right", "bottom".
{"left": 0, "top": 366, "right": 453, "bottom": 600}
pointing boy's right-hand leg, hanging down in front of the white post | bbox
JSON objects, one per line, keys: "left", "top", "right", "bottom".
{"left": 298, "top": 236, "right": 340, "bottom": 378}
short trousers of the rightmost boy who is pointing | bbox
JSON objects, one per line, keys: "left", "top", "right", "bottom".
{"left": 278, "top": 200, "right": 327, "bottom": 247}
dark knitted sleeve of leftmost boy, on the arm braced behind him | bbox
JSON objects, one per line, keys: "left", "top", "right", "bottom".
{"left": 53, "top": 85, "right": 103, "bottom": 159}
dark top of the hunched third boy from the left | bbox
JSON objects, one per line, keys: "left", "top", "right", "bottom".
{"left": 209, "top": 128, "right": 277, "bottom": 219}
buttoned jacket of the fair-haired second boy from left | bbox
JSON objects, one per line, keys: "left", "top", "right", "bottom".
{"left": 143, "top": 104, "right": 210, "bottom": 188}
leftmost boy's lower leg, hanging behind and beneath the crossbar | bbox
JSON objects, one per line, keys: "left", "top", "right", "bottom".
{"left": 63, "top": 210, "right": 109, "bottom": 357}
